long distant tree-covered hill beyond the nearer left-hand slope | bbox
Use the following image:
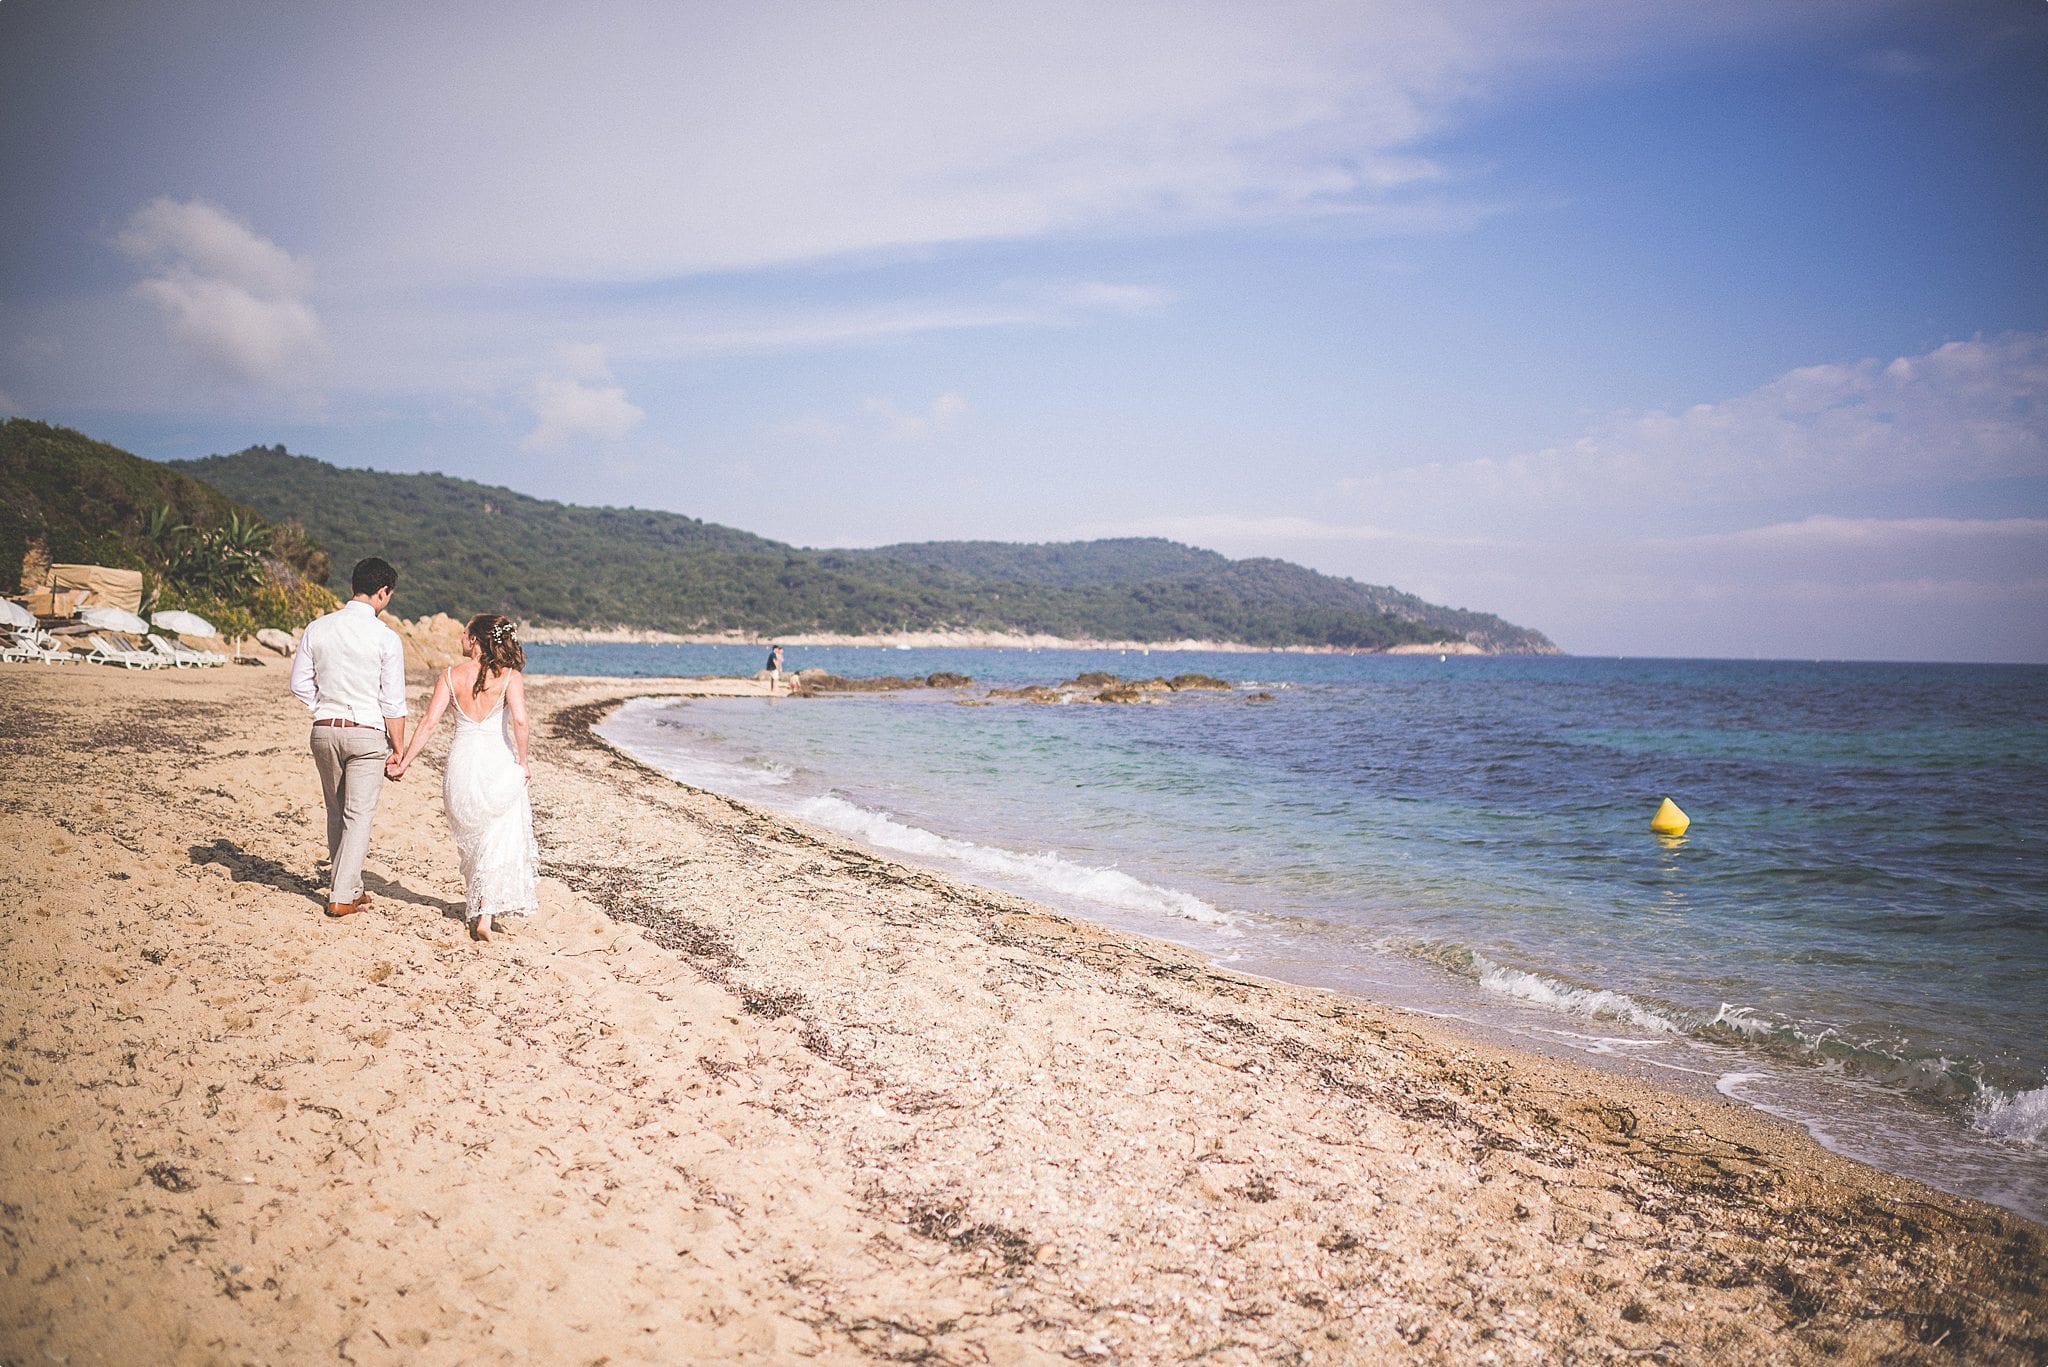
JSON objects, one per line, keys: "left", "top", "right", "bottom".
{"left": 178, "top": 447, "right": 1554, "bottom": 652}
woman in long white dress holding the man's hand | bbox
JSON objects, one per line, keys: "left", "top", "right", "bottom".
{"left": 391, "top": 613, "right": 541, "bottom": 941}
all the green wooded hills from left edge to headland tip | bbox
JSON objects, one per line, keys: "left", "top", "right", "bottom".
{"left": 0, "top": 418, "right": 1561, "bottom": 654}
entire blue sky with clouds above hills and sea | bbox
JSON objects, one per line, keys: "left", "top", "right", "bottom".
{"left": 0, "top": 0, "right": 2048, "bottom": 660}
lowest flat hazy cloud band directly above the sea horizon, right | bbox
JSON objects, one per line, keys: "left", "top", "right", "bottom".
{"left": 1059, "top": 514, "right": 2048, "bottom": 662}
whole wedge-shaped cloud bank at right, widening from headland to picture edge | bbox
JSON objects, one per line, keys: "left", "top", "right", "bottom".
{"left": 1075, "top": 334, "right": 2048, "bottom": 660}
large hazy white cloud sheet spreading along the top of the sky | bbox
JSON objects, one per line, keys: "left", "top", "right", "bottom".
{"left": 264, "top": 0, "right": 1858, "bottom": 281}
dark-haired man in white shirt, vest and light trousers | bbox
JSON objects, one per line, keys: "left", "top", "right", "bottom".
{"left": 291, "top": 555, "right": 406, "bottom": 916}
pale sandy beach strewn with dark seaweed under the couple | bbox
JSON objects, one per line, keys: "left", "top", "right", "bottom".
{"left": 0, "top": 662, "right": 2048, "bottom": 1365}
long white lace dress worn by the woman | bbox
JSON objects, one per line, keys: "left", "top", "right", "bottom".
{"left": 440, "top": 680, "right": 541, "bottom": 920}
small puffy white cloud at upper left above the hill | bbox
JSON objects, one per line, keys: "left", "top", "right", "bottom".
{"left": 117, "top": 199, "right": 326, "bottom": 383}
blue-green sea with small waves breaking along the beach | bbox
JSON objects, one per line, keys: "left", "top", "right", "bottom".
{"left": 530, "top": 646, "right": 2048, "bottom": 1219}
